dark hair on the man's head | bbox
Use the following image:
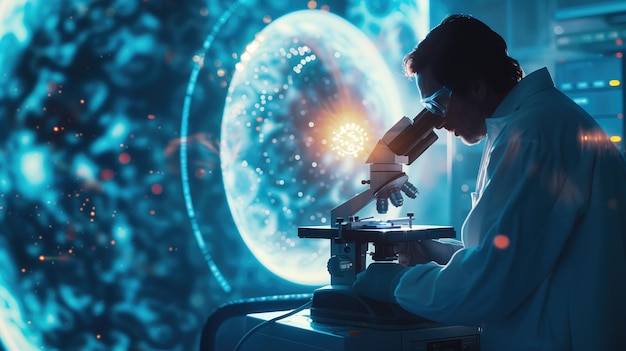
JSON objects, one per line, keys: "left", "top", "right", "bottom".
{"left": 404, "top": 14, "right": 524, "bottom": 92}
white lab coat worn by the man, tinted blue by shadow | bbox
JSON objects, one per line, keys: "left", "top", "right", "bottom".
{"left": 395, "top": 68, "right": 626, "bottom": 351}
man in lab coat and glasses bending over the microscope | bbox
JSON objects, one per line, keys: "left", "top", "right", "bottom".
{"left": 354, "top": 15, "right": 626, "bottom": 351}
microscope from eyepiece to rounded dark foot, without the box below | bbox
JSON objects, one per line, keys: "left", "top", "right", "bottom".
{"left": 298, "top": 109, "right": 456, "bottom": 328}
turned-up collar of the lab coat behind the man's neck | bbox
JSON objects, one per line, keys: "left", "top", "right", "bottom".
{"left": 485, "top": 67, "right": 554, "bottom": 140}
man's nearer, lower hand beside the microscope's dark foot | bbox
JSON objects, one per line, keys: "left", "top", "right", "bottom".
{"left": 353, "top": 263, "right": 408, "bottom": 302}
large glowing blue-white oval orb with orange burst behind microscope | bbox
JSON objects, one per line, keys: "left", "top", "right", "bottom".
{"left": 220, "top": 10, "right": 401, "bottom": 285}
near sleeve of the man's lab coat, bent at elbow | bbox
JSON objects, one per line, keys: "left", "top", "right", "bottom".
{"left": 395, "top": 140, "right": 590, "bottom": 325}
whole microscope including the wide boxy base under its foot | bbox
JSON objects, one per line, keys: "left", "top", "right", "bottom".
{"left": 239, "top": 110, "right": 480, "bottom": 351}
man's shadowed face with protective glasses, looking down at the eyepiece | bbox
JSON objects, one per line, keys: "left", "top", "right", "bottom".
{"left": 417, "top": 69, "right": 487, "bottom": 145}
